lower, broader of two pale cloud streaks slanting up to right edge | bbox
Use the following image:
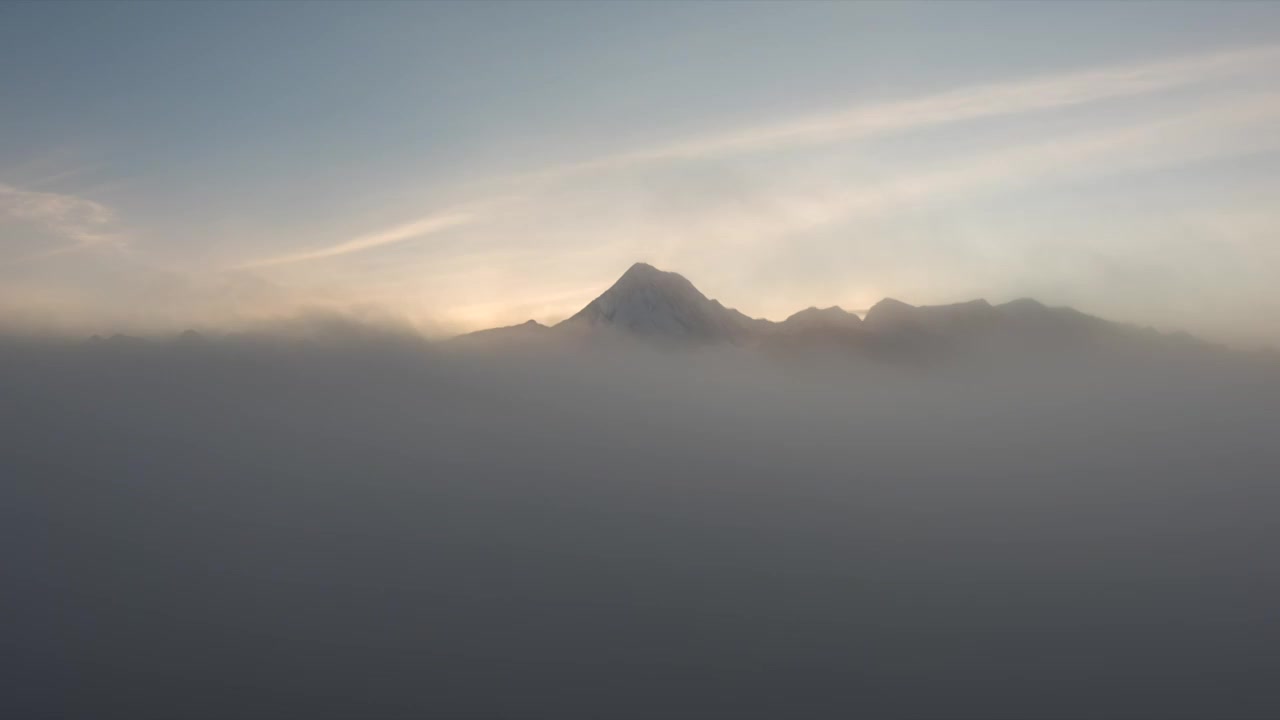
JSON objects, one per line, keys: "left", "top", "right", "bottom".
{"left": 448, "top": 94, "right": 1280, "bottom": 304}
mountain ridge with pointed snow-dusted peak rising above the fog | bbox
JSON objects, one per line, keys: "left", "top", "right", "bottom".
{"left": 457, "top": 263, "right": 1218, "bottom": 355}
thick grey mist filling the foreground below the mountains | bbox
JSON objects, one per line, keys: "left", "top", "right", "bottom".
{"left": 0, "top": 329, "right": 1280, "bottom": 719}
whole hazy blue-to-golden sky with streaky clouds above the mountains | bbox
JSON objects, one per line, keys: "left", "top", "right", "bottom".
{"left": 0, "top": 3, "right": 1280, "bottom": 343}
